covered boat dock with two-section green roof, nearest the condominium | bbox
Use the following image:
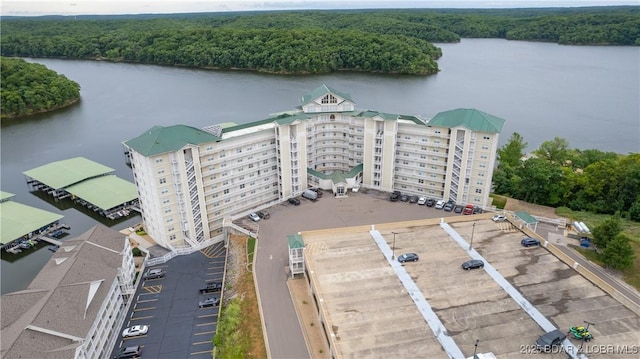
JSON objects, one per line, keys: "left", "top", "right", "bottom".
{"left": 23, "top": 157, "right": 139, "bottom": 220}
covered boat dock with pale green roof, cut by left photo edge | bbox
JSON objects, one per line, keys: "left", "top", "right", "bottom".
{"left": 0, "top": 191, "right": 69, "bottom": 253}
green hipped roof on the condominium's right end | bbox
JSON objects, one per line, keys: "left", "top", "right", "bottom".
{"left": 427, "top": 108, "right": 505, "bottom": 133}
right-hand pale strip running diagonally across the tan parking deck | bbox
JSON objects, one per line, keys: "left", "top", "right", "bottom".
{"left": 440, "top": 221, "right": 587, "bottom": 359}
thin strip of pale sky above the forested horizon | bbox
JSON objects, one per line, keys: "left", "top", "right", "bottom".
{"left": 0, "top": 0, "right": 640, "bottom": 16}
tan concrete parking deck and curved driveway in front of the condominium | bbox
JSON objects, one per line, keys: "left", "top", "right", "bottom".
{"left": 252, "top": 192, "right": 640, "bottom": 358}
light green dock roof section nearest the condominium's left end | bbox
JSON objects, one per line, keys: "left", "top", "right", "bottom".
{"left": 66, "top": 175, "right": 138, "bottom": 209}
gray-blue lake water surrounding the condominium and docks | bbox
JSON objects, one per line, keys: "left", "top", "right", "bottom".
{"left": 0, "top": 39, "right": 640, "bottom": 293}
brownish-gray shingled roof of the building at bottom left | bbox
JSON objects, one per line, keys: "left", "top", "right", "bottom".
{"left": 0, "top": 225, "right": 126, "bottom": 358}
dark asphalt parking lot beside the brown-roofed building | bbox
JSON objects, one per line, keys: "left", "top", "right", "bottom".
{"left": 112, "top": 243, "right": 226, "bottom": 359}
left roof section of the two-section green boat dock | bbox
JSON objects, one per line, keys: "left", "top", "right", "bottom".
{"left": 23, "top": 157, "right": 114, "bottom": 189}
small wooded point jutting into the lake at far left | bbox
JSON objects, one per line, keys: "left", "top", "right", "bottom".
{"left": 0, "top": 57, "right": 80, "bottom": 119}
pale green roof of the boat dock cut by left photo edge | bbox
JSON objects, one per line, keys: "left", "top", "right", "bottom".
{"left": 0, "top": 201, "right": 63, "bottom": 244}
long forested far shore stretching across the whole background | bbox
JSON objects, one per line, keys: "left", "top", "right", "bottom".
{"left": 1, "top": 6, "right": 640, "bottom": 75}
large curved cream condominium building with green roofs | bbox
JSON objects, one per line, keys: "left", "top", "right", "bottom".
{"left": 124, "top": 85, "right": 504, "bottom": 248}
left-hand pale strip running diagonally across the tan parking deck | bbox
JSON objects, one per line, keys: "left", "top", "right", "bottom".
{"left": 369, "top": 229, "right": 465, "bottom": 359}
